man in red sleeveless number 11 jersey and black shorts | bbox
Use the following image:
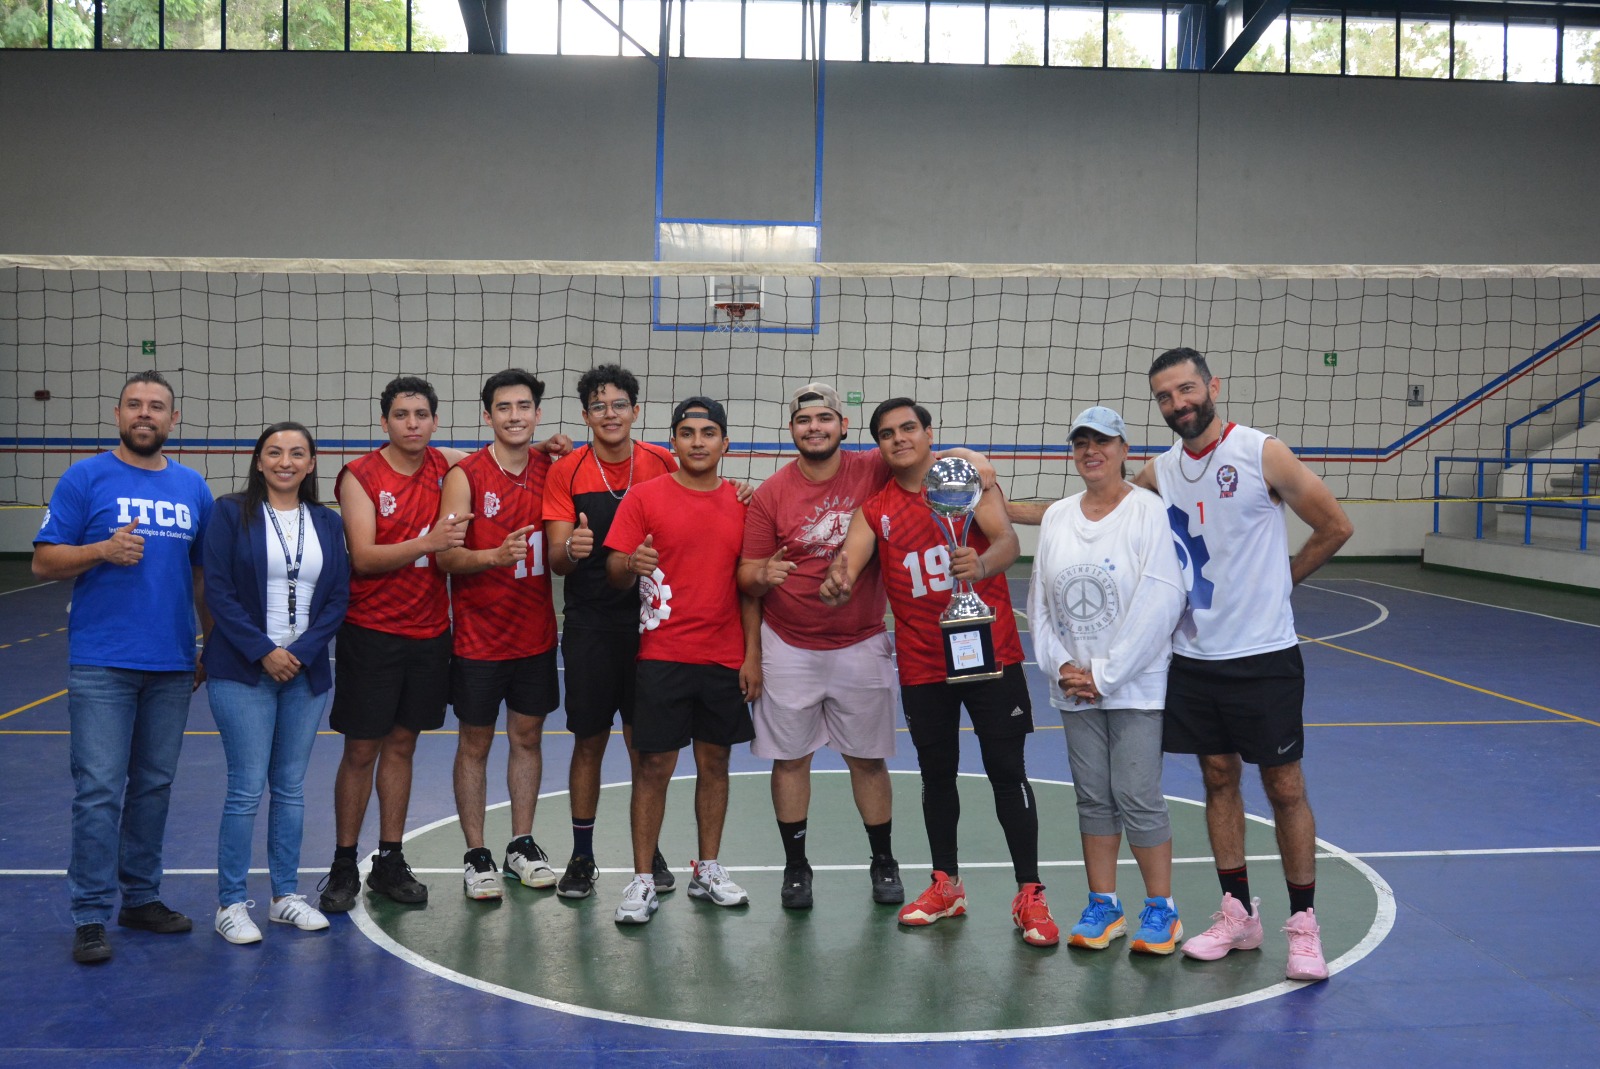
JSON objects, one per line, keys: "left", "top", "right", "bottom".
{"left": 437, "top": 368, "right": 562, "bottom": 899}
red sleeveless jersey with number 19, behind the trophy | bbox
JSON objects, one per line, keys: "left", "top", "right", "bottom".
{"left": 861, "top": 480, "right": 1022, "bottom": 687}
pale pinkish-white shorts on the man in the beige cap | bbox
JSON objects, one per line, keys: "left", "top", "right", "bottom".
{"left": 750, "top": 623, "right": 899, "bottom": 760}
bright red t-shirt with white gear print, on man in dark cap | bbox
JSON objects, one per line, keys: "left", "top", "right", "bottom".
{"left": 605, "top": 477, "right": 744, "bottom": 669}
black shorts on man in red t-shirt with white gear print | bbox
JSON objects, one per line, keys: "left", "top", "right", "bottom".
{"left": 634, "top": 661, "right": 755, "bottom": 754}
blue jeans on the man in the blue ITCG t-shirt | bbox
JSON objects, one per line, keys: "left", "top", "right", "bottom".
{"left": 67, "top": 664, "right": 194, "bottom": 925}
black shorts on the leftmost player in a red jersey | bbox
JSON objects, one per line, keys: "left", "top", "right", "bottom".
{"left": 328, "top": 623, "right": 450, "bottom": 739}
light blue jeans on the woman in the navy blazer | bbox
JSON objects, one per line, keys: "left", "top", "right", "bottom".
{"left": 206, "top": 672, "right": 328, "bottom": 906}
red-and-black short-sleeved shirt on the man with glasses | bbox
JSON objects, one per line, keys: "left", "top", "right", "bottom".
{"left": 544, "top": 442, "right": 678, "bottom": 631}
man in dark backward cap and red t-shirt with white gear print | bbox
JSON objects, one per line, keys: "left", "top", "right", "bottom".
{"left": 605, "top": 397, "right": 762, "bottom": 923}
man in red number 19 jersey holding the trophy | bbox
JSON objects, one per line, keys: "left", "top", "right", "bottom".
{"left": 818, "top": 397, "right": 1059, "bottom": 946}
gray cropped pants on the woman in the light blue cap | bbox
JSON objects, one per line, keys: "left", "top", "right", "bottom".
{"left": 1061, "top": 709, "right": 1173, "bottom": 847}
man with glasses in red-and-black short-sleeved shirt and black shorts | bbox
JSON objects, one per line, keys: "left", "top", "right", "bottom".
{"left": 544, "top": 363, "right": 678, "bottom": 898}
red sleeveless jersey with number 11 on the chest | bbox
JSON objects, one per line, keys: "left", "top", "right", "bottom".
{"left": 450, "top": 446, "right": 555, "bottom": 661}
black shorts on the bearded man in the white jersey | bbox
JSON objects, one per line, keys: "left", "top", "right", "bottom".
{"left": 1162, "top": 645, "right": 1306, "bottom": 767}
